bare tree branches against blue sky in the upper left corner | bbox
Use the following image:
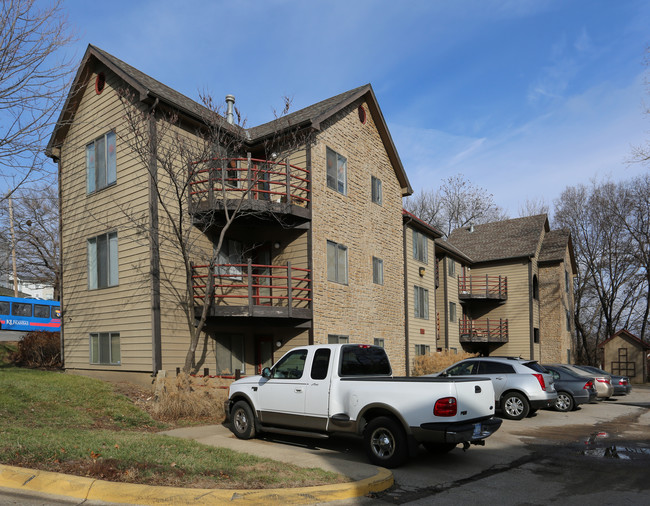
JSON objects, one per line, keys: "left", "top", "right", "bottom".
{"left": 0, "top": 0, "right": 72, "bottom": 200}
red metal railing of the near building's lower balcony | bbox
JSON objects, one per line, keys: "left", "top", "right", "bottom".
{"left": 192, "top": 261, "right": 312, "bottom": 309}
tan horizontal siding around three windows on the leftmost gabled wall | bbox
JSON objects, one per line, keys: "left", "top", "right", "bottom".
{"left": 60, "top": 65, "right": 151, "bottom": 371}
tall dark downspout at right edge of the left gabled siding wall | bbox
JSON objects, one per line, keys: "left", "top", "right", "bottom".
{"left": 148, "top": 99, "right": 162, "bottom": 377}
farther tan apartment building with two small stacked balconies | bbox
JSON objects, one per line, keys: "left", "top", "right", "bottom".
{"left": 404, "top": 215, "right": 576, "bottom": 363}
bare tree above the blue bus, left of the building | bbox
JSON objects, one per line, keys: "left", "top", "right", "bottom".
{"left": 2, "top": 185, "right": 61, "bottom": 299}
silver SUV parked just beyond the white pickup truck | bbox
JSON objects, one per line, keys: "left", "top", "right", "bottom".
{"left": 429, "top": 357, "right": 557, "bottom": 420}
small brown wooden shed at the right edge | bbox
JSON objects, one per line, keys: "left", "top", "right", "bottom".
{"left": 598, "top": 329, "right": 650, "bottom": 384}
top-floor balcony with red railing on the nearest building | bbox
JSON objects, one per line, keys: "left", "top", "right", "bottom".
{"left": 189, "top": 156, "right": 311, "bottom": 218}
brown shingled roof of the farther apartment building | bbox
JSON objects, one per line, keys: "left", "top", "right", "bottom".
{"left": 447, "top": 214, "right": 550, "bottom": 263}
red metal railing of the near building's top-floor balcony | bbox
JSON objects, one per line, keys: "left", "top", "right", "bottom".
{"left": 189, "top": 157, "right": 310, "bottom": 207}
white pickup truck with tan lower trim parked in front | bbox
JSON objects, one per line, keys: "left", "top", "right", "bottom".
{"left": 226, "top": 344, "right": 501, "bottom": 467}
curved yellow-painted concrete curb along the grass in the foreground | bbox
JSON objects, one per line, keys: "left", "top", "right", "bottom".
{"left": 0, "top": 464, "right": 394, "bottom": 505}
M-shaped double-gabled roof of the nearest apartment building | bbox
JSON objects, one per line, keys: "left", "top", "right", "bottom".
{"left": 46, "top": 44, "right": 413, "bottom": 196}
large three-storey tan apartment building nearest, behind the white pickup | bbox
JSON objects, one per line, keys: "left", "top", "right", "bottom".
{"left": 47, "top": 46, "right": 412, "bottom": 382}
